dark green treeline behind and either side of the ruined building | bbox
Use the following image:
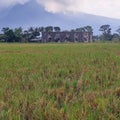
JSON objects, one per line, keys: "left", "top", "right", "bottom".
{"left": 0, "top": 25, "right": 120, "bottom": 42}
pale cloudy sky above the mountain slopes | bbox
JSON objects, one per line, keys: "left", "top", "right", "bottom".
{"left": 0, "top": 0, "right": 120, "bottom": 19}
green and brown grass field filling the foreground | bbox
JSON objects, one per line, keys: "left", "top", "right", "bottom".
{"left": 0, "top": 43, "right": 120, "bottom": 120}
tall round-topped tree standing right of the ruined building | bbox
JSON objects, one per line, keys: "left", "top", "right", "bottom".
{"left": 99, "top": 25, "right": 112, "bottom": 40}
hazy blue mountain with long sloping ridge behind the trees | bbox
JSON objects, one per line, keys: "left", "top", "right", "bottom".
{"left": 0, "top": 1, "right": 120, "bottom": 34}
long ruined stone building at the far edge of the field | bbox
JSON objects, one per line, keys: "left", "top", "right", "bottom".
{"left": 41, "top": 32, "right": 93, "bottom": 43}
